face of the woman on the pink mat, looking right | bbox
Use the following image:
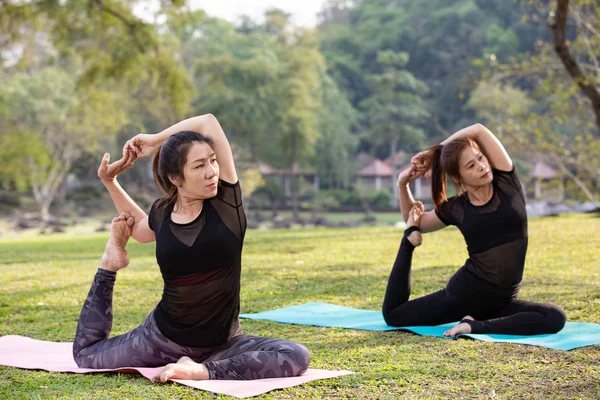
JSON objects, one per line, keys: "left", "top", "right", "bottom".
{"left": 179, "top": 142, "right": 219, "bottom": 199}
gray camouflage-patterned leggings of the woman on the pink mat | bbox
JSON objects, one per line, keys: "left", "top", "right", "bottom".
{"left": 73, "top": 269, "right": 310, "bottom": 380}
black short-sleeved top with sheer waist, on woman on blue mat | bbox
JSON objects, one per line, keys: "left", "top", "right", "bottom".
{"left": 435, "top": 168, "right": 528, "bottom": 287}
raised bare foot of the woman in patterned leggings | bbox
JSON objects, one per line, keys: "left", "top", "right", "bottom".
{"left": 100, "top": 213, "right": 135, "bottom": 272}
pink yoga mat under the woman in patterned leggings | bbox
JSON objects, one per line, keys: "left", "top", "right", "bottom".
{"left": 0, "top": 335, "right": 353, "bottom": 398}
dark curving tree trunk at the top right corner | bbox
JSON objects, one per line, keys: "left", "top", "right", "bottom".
{"left": 548, "top": 0, "right": 600, "bottom": 138}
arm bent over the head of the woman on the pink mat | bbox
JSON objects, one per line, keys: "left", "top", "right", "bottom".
{"left": 125, "top": 114, "right": 238, "bottom": 183}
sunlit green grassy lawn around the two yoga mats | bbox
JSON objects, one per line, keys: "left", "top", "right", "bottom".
{"left": 0, "top": 215, "right": 600, "bottom": 399}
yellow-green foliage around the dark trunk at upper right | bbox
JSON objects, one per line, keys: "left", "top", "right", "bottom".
{"left": 468, "top": 2, "right": 600, "bottom": 204}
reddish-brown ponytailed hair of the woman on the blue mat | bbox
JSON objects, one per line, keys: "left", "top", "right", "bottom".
{"left": 425, "top": 138, "right": 479, "bottom": 208}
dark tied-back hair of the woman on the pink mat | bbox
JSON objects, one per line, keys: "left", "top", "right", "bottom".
{"left": 152, "top": 131, "right": 212, "bottom": 212}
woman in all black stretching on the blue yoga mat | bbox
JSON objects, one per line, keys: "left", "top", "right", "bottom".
{"left": 383, "top": 124, "right": 566, "bottom": 336}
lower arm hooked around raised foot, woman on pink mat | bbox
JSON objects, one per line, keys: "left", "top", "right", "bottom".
{"left": 98, "top": 150, "right": 156, "bottom": 243}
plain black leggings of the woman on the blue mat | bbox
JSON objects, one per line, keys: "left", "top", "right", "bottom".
{"left": 383, "top": 234, "right": 567, "bottom": 335}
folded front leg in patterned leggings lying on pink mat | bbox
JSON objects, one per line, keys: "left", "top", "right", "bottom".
{"left": 204, "top": 335, "right": 310, "bottom": 380}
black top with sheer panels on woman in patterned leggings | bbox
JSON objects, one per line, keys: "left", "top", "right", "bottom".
{"left": 148, "top": 181, "right": 246, "bottom": 347}
